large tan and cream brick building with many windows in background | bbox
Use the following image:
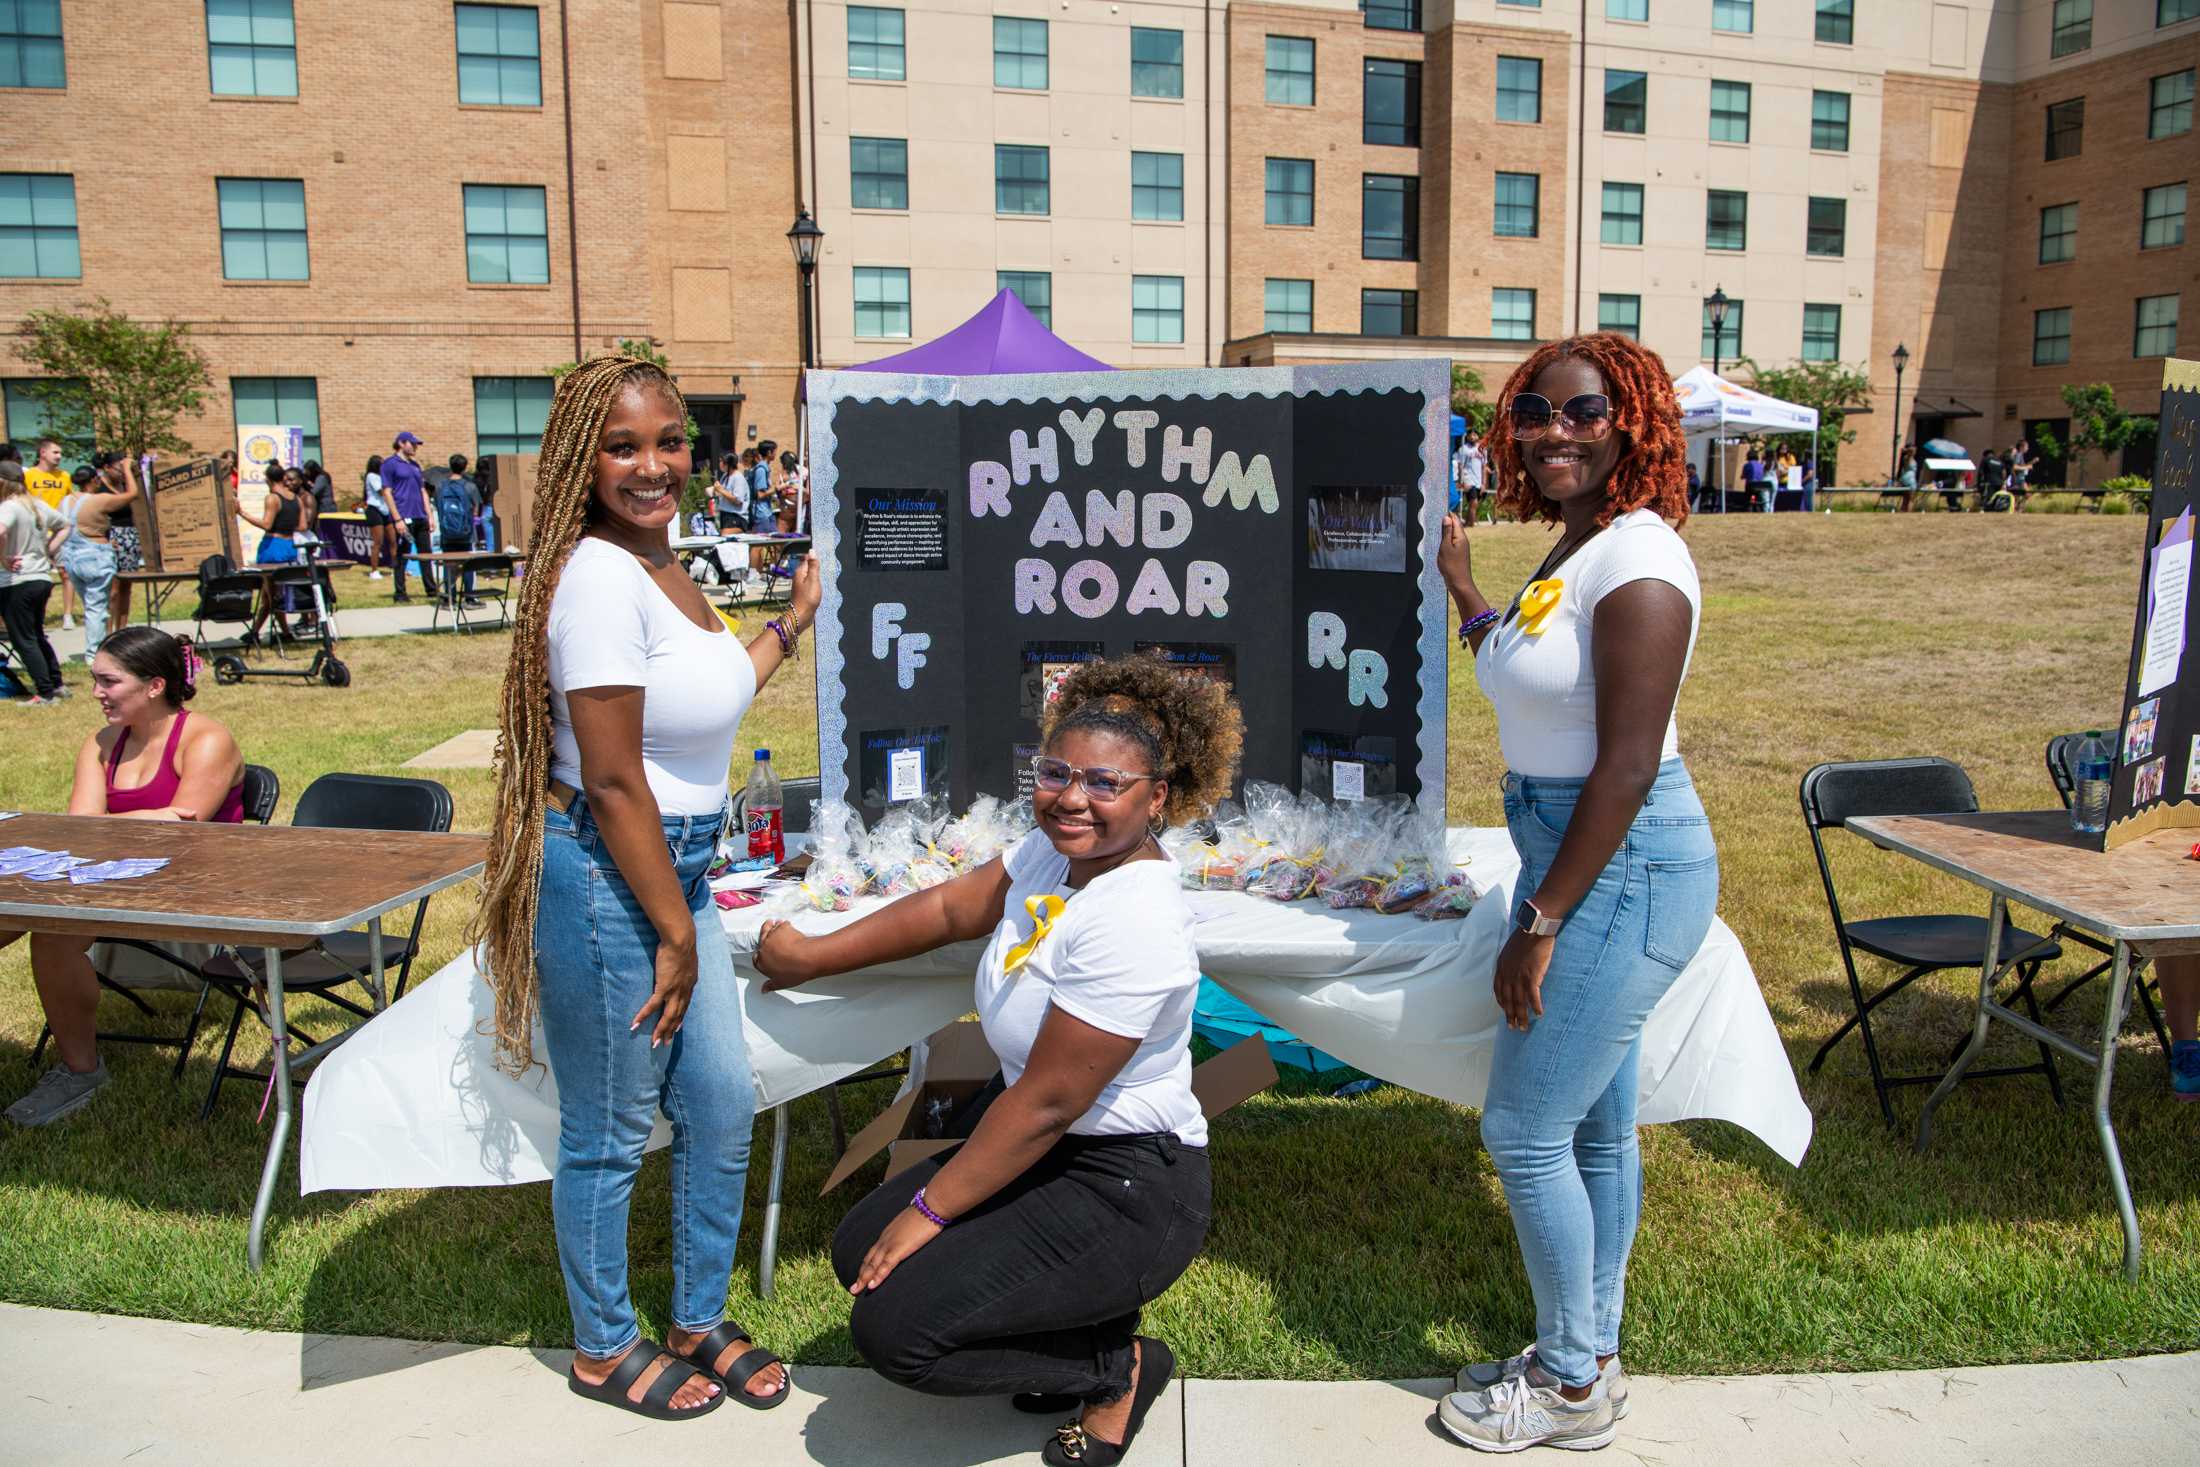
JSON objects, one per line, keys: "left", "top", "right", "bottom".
{"left": 0, "top": 0, "right": 2200, "bottom": 482}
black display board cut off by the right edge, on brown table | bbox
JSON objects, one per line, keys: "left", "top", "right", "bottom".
{"left": 2099, "top": 361, "right": 2200, "bottom": 849}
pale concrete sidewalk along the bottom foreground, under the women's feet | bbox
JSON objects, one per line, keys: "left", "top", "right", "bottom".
{"left": 0, "top": 1304, "right": 2200, "bottom": 1467}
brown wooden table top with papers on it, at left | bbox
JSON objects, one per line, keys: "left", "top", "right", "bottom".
{"left": 0, "top": 814, "right": 488, "bottom": 946}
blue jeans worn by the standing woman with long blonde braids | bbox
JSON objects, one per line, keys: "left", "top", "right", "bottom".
{"left": 535, "top": 796, "right": 757, "bottom": 1359}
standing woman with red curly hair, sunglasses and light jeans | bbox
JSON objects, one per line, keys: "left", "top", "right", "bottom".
{"left": 1437, "top": 332, "right": 1718, "bottom": 1452}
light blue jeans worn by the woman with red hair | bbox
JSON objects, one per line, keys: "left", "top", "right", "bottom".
{"left": 1483, "top": 759, "right": 1718, "bottom": 1386}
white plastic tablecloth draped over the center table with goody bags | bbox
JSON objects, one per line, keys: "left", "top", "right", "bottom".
{"left": 299, "top": 829, "right": 1811, "bottom": 1192}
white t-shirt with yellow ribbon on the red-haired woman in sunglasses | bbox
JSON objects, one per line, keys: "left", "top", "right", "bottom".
{"left": 1474, "top": 510, "right": 1703, "bottom": 779}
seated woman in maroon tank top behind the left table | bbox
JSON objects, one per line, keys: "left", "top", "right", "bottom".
{"left": 0, "top": 627, "right": 244, "bottom": 1126}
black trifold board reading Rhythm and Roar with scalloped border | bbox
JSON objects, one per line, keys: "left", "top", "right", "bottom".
{"left": 810, "top": 361, "right": 1450, "bottom": 818}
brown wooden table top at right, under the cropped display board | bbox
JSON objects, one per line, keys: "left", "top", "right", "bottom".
{"left": 1848, "top": 809, "right": 2200, "bottom": 952}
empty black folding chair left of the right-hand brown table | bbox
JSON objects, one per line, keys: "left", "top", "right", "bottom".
{"left": 1797, "top": 759, "right": 2061, "bottom": 1126}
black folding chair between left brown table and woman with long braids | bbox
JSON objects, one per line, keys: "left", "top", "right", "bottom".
{"left": 198, "top": 774, "right": 453, "bottom": 1119}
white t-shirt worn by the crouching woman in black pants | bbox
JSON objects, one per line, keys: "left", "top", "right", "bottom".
{"left": 977, "top": 831, "right": 1208, "bottom": 1146}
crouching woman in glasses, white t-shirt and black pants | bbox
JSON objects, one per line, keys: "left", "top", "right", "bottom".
{"left": 757, "top": 658, "right": 1243, "bottom": 1467}
